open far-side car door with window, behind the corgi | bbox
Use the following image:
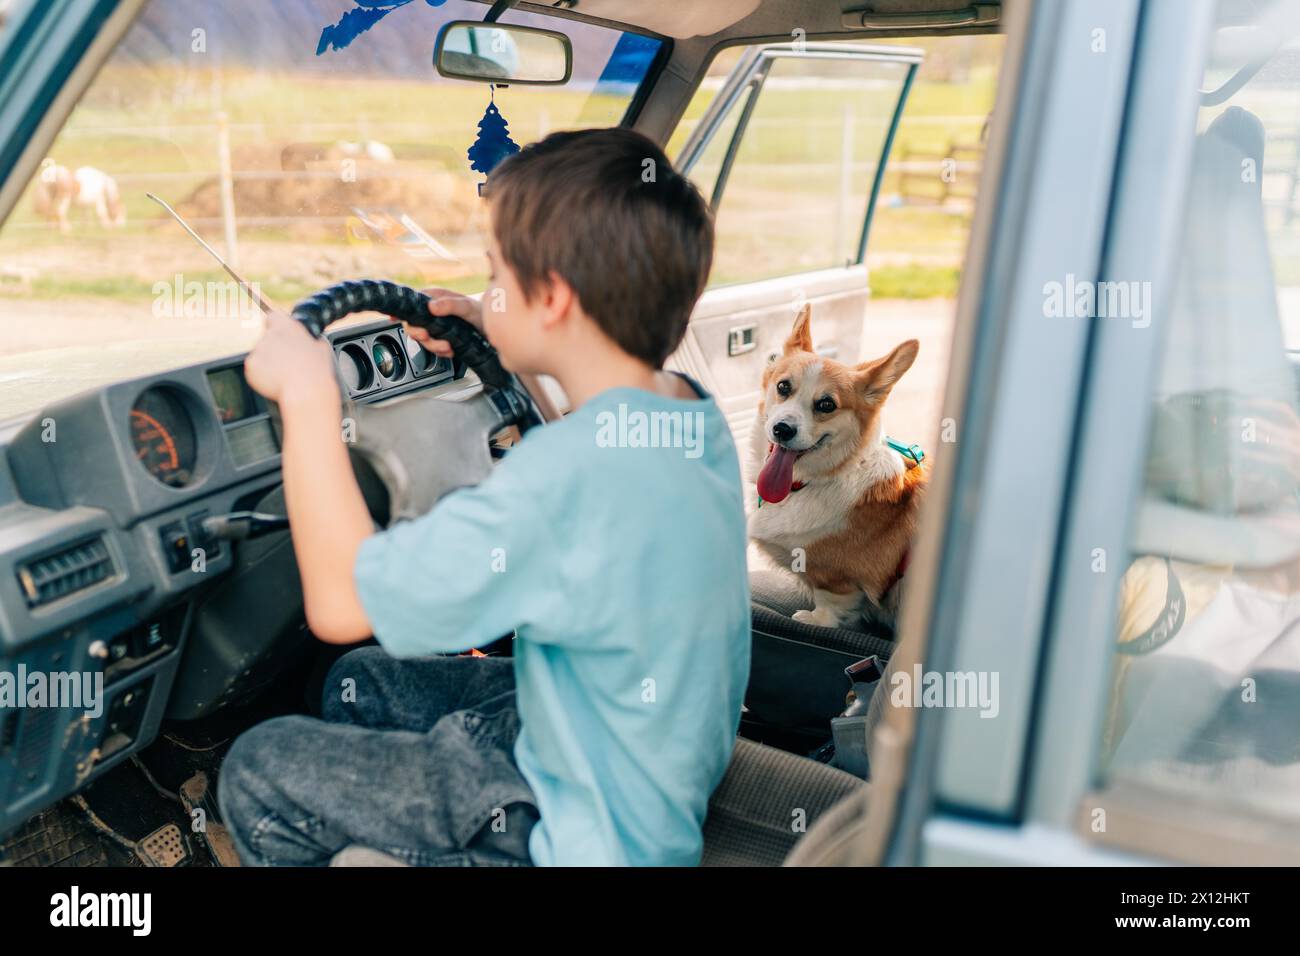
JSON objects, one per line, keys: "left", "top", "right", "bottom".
{"left": 673, "top": 43, "right": 922, "bottom": 447}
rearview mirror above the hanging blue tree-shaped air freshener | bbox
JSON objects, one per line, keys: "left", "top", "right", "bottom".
{"left": 433, "top": 20, "right": 573, "bottom": 86}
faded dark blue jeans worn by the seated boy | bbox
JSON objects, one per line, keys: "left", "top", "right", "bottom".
{"left": 217, "top": 646, "right": 538, "bottom": 866}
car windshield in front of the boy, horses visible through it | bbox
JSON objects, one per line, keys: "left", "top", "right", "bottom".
{"left": 0, "top": 0, "right": 660, "bottom": 418}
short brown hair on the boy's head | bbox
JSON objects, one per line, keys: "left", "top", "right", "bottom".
{"left": 484, "top": 129, "right": 714, "bottom": 368}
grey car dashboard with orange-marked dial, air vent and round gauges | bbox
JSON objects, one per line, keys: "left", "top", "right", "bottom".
{"left": 0, "top": 320, "right": 477, "bottom": 834}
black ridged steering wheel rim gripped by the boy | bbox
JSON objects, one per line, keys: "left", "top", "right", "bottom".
{"left": 293, "top": 278, "right": 542, "bottom": 432}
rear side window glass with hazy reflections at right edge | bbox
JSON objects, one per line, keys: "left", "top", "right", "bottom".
{"left": 1101, "top": 4, "right": 1300, "bottom": 822}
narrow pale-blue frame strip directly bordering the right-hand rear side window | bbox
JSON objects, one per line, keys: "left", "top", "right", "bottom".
{"left": 1028, "top": 0, "right": 1213, "bottom": 825}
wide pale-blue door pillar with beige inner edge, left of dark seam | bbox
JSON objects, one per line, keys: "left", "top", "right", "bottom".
{"left": 878, "top": 0, "right": 1141, "bottom": 864}
